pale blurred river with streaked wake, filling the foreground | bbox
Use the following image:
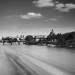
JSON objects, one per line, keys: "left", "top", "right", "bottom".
{"left": 0, "top": 43, "right": 75, "bottom": 75}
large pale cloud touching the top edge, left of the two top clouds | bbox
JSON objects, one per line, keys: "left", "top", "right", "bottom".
{"left": 33, "top": 0, "right": 54, "bottom": 7}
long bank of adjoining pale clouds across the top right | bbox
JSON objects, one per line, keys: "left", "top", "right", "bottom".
{"left": 33, "top": 0, "right": 75, "bottom": 12}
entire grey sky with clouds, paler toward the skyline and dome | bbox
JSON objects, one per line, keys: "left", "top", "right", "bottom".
{"left": 0, "top": 0, "right": 75, "bottom": 36}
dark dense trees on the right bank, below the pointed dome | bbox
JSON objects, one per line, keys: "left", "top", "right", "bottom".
{"left": 47, "top": 32, "right": 75, "bottom": 47}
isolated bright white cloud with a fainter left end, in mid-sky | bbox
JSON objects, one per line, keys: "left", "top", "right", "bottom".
{"left": 20, "top": 12, "right": 42, "bottom": 19}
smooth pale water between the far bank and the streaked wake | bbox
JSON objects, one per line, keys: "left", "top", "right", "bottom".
{"left": 6, "top": 44, "right": 75, "bottom": 72}
